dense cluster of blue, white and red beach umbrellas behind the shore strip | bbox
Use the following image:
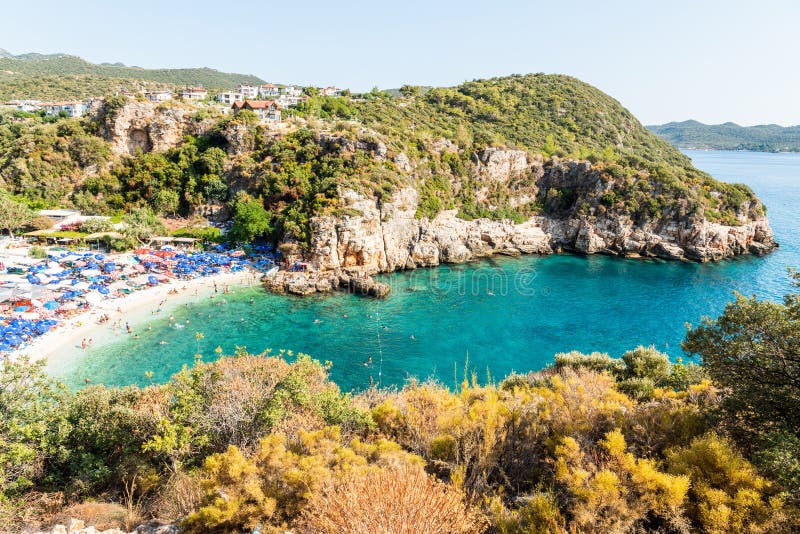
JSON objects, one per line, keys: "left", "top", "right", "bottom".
{"left": 0, "top": 245, "right": 277, "bottom": 356}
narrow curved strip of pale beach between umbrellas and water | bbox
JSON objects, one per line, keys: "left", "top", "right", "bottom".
{"left": 10, "top": 269, "right": 261, "bottom": 367}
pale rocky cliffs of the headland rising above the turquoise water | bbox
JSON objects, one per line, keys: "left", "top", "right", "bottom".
{"left": 302, "top": 149, "right": 776, "bottom": 274}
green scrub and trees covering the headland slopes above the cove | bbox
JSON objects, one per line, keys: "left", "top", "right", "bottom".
{"left": 0, "top": 74, "right": 763, "bottom": 247}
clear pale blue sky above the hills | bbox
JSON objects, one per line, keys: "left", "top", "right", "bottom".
{"left": 6, "top": 0, "right": 800, "bottom": 125}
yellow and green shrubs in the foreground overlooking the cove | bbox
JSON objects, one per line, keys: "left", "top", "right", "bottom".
{"left": 0, "top": 278, "right": 800, "bottom": 534}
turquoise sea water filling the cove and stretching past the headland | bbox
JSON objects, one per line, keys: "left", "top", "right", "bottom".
{"left": 54, "top": 151, "right": 800, "bottom": 390}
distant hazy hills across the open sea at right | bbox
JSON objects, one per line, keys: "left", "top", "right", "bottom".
{"left": 647, "top": 120, "right": 800, "bottom": 152}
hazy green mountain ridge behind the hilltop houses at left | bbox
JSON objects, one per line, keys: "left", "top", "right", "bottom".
{"left": 0, "top": 49, "right": 264, "bottom": 100}
